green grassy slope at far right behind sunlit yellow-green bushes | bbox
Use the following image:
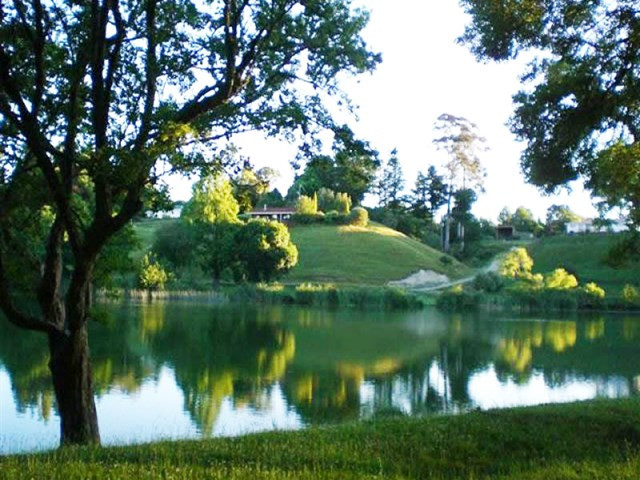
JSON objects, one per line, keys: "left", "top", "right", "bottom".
{"left": 528, "top": 235, "right": 640, "bottom": 294}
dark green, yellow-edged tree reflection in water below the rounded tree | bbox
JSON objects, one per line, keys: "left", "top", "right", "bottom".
{"left": 140, "top": 304, "right": 296, "bottom": 435}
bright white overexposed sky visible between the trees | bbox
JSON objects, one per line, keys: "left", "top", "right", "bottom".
{"left": 173, "top": 0, "right": 596, "bottom": 221}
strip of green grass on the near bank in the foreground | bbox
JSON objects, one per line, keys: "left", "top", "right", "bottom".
{"left": 0, "top": 400, "right": 640, "bottom": 480}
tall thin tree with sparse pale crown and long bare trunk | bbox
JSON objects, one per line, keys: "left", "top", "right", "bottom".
{"left": 433, "top": 113, "right": 486, "bottom": 252}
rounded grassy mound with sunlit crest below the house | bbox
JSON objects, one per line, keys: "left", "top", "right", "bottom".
{"left": 285, "top": 224, "right": 469, "bottom": 285}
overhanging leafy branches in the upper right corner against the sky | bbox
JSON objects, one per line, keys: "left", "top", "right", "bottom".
{"left": 461, "top": 0, "right": 640, "bottom": 229}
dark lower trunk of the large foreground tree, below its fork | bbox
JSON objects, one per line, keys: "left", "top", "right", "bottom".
{"left": 49, "top": 322, "right": 100, "bottom": 445}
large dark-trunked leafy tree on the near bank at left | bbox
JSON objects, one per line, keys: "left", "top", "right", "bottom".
{"left": 0, "top": 0, "right": 380, "bottom": 444}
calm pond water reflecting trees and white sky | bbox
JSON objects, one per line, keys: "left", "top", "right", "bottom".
{"left": 0, "top": 303, "right": 640, "bottom": 453}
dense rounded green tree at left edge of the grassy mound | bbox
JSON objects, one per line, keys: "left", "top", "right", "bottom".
{"left": 235, "top": 220, "right": 298, "bottom": 282}
